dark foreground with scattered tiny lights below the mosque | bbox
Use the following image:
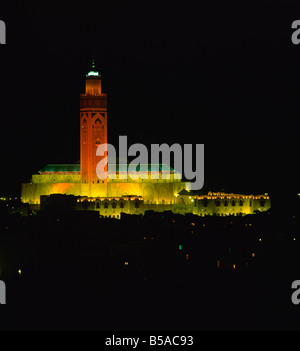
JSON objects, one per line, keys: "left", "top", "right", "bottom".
{"left": 0, "top": 205, "right": 300, "bottom": 330}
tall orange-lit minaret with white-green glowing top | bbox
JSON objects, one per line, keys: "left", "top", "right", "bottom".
{"left": 80, "top": 60, "right": 107, "bottom": 192}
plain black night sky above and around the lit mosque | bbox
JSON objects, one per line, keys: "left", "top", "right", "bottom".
{"left": 0, "top": 0, "right": 300, "bottom": 205}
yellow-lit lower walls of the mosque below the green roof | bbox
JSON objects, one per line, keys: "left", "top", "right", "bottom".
{"left": 22, "top": 181, "right": 271, "bottom": 218}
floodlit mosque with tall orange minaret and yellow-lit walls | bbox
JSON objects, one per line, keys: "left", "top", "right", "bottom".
{"left": 21, "top": 61, "right": 270, "bottom": 218}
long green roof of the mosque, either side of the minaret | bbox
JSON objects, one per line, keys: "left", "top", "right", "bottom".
{"left": 39, "top": 163, "right": 178, "bottom": 173}
